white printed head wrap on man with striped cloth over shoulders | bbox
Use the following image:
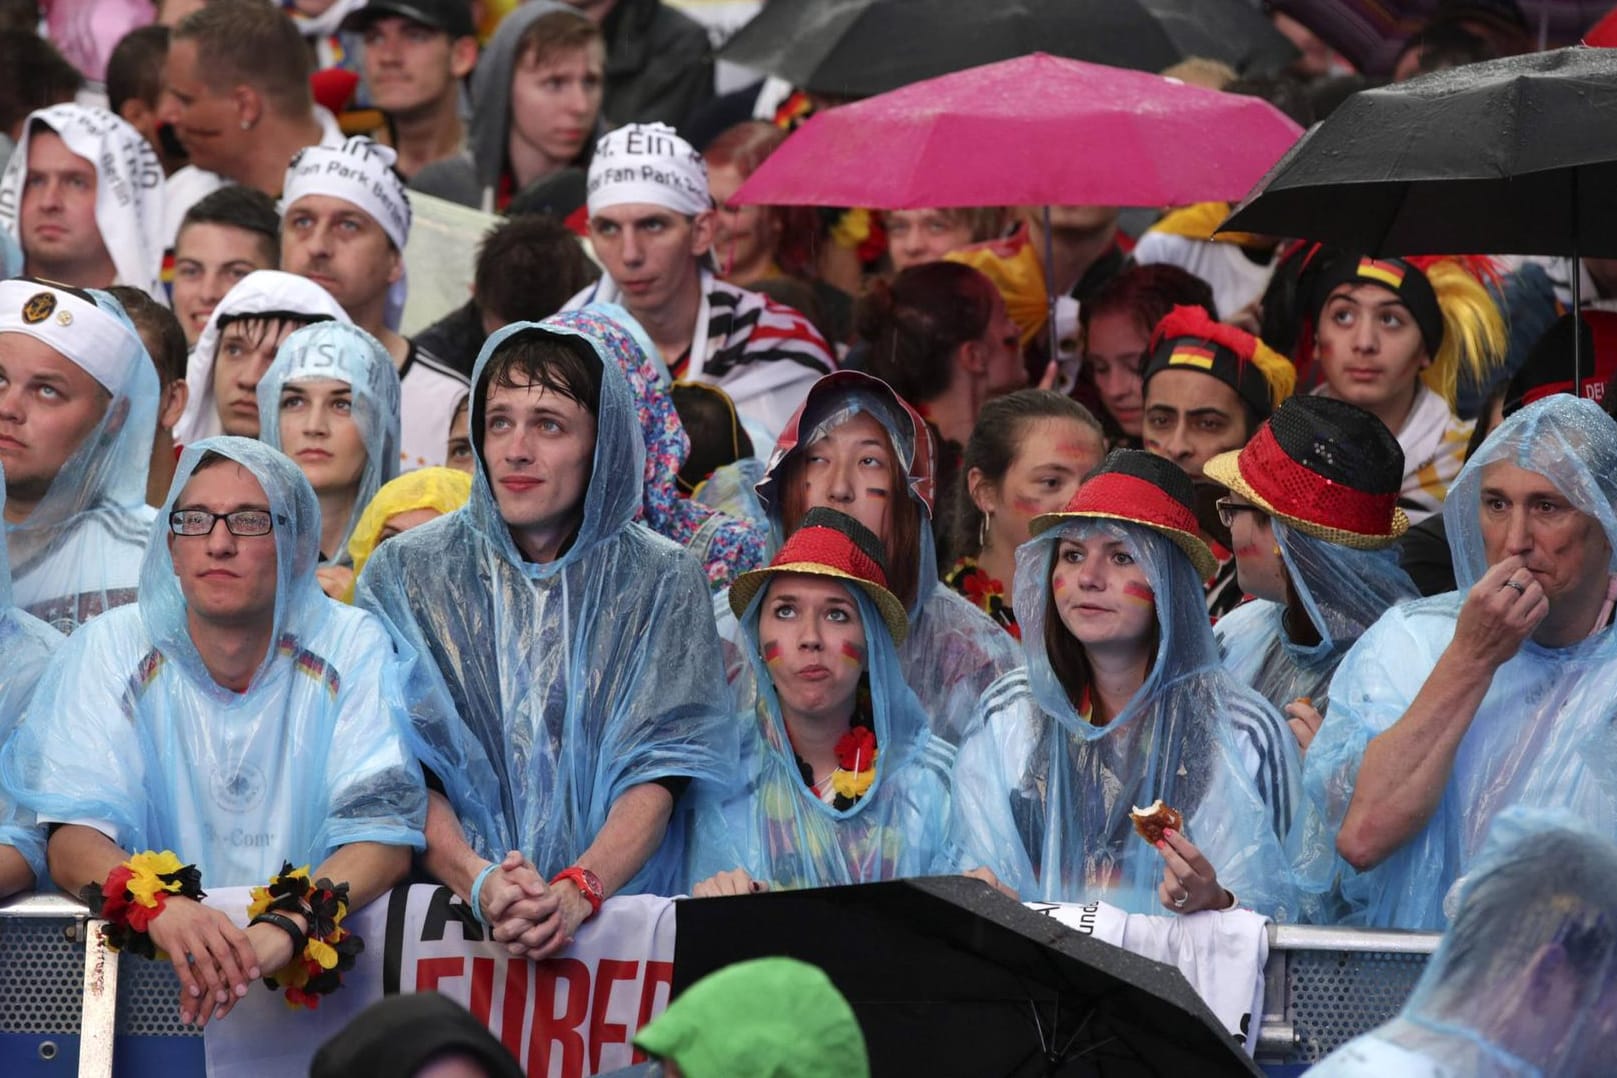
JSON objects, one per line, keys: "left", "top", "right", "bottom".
{"left": 589, "top": 123, "right": 713, "bottom": 217}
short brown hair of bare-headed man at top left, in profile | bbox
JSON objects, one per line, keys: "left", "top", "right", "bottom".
{"left": 168, "top": 0, "right": 314, "bottom": 116}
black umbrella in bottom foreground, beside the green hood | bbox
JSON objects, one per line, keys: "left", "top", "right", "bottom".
{"left": 674, "top": 876, "right": 1261, "bottom": 1078}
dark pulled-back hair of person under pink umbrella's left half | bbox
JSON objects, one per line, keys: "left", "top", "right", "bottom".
{"left": 854, "top": 262, "right": 999, "bottom": 404}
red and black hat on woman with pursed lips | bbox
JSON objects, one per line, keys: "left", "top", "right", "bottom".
{"left": 729, "top": 507, "right": 909, "bottom": 645}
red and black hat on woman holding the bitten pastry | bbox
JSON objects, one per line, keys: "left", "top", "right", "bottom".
{"left": 1028, "top": 449, "right": 1218, "bottom": 580}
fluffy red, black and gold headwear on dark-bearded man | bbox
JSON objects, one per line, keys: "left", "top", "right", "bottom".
{"left": 1142, "top": 307, "right": 1297, "bottom": 419}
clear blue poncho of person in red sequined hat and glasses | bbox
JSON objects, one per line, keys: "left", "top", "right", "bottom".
{"left": 1213, "top": 517, "right": 1420, "bottom": 714}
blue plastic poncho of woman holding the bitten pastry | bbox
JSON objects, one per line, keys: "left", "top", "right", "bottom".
{"left": 951, "top": 519, "right": 1295, "bottom": 921}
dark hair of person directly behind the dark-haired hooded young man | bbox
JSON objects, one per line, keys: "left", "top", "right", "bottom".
{"left": 472, "top": 213, "right": 600, "bottom": 323}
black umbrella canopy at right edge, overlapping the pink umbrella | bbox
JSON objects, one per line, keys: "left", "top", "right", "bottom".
{"left": 1224, "top": 45, "right": 1617, "bottom": 257}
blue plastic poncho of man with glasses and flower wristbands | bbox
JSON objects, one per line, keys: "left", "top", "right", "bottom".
{"left": 0, "top": 438, "right": 427, "bottom": 886}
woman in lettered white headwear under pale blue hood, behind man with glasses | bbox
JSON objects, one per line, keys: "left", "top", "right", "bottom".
{"left": 257, "top": 322, "right": 399, "bottom": 598}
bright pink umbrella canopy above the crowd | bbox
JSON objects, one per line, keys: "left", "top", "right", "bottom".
{"left": 731, "top": 52, "right": 1302, "bottom": 210}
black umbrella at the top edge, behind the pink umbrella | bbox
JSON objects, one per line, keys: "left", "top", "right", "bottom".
{"left": 720, "top": 0, "right": 1297, "bottom": 97}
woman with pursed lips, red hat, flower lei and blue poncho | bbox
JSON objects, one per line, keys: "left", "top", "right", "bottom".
{"left": 689, "top": 509, "right": 954, "bottom": 899}
